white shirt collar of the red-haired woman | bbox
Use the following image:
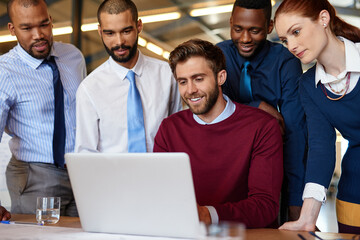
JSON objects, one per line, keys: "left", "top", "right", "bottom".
{"left": 315, "top": 36, "right": 360, "bottom": 87}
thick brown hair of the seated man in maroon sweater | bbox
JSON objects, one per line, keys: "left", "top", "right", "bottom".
{"left": 169, "top": 39, "right": 226, "bottom": 77}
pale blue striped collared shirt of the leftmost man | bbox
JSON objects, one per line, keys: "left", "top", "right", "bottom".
{"left": 0, "top": 42, "right": 86, "bottom": 163}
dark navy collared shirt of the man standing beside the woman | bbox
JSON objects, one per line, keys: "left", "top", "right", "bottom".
{"left": 217, "top": 40, "right": 307, "bottom": 206}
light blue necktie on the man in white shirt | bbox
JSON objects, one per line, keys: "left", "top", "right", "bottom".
{"left": 126, "top": 70, "right": 146, "bottom": 152}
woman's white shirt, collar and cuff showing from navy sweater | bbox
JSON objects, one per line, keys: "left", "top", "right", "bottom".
{"left": 303, "top": 37, "right": 360, "bottom": 203}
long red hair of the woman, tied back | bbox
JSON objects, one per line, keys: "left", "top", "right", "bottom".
{"left": 275, "top": 0, "right": 360, "bottom": 42}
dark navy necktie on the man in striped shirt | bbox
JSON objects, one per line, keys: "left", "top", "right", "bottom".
{"left": 44, "top": 56, "right": 66, "bottom": 168}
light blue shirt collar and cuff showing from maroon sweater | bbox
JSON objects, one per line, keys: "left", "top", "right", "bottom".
{"left": 193, "top": 94, "right": 236, "bottom": 223}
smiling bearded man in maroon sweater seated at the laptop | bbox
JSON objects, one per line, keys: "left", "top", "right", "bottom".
{"left": 154, "top": 39, "right": 283, "bottom": 228}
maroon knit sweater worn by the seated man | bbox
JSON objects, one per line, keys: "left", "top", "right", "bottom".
{"left": 154, "top": 103, "right": 283, "bottom": 228}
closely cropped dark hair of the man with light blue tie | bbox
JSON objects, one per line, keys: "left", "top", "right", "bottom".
{"left": 97, "top": 0, "right": 138, "bottom": 24}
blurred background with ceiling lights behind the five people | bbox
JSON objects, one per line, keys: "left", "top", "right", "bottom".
{"left": 0, "top": 0, "right": 360, "bottom": 232}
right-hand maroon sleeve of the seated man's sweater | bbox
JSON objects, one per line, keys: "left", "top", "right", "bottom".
{"left": 214, "top": 119, "right": 283, "bottom": 228}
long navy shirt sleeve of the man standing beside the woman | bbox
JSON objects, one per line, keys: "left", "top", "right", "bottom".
{"left": 279, "top": 55, "right": 307, "bottom": 206}
